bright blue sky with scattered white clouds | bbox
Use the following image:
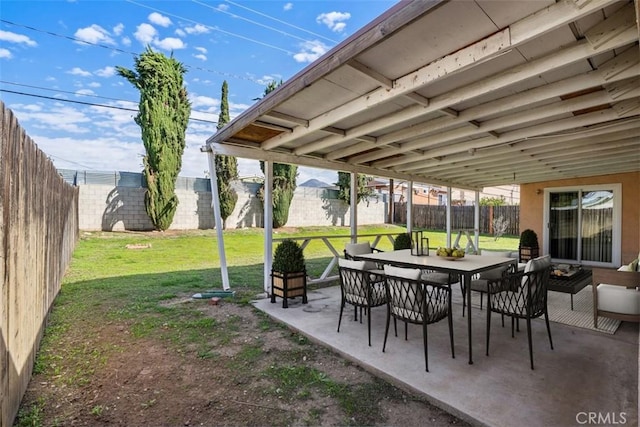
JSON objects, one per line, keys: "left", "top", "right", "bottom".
{"left": 0, "top": 0, "right": 395, "bottom": 183}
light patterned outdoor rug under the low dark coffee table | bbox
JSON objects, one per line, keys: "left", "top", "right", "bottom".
{"left": 547, "top": 286, "right": 620, "bottom": 334}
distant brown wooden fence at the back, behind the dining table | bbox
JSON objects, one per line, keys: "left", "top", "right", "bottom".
{"left": 394, "top": 203, "right": 520, "bottom": 236}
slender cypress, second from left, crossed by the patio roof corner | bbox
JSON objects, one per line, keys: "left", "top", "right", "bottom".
{"left": 215, "top": 80, "right": 238, "bottom": 229}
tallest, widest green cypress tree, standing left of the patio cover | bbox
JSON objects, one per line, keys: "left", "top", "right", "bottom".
{"left": 116, "top": 47, "right": 191, "bottom": 231}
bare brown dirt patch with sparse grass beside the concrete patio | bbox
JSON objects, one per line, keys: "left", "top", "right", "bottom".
{"left": 17, "top": 298, "right": 466, "bottom": 426}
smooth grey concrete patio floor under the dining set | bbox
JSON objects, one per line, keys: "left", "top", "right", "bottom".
{"left": 254, "top": 286, "right": 639, "bottom": 427}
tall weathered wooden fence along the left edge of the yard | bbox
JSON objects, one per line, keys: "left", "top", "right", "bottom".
{"left": 0, "top": 101, "right": 78, "bottom": 427}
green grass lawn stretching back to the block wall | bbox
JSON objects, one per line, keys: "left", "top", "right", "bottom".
{"left": 18, "top": 225, "right": 518, "bottom": 426}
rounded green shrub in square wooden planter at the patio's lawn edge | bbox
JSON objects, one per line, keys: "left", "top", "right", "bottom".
{"left": 271, "top": 239, "right": 307, "bottom": 308}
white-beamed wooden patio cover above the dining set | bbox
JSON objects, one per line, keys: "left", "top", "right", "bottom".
{"left": 204, "top": 0, "right": 640, "bottom": 290}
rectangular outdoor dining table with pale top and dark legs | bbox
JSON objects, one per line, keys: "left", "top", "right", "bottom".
{"left": 354, "top": 249, "right": 518, "bottom": 364}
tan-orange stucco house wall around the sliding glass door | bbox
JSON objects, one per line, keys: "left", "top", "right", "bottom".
{"left": 520, "top": 172, "right": 640, "bottom": 264}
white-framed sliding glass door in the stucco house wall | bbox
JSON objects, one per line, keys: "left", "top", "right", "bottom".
{"left": 544, "top": 185, "right": 621, "bottom": 265}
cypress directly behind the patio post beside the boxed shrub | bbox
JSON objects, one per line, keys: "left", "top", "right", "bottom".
{"left": 256, "top": 80, "right": 298, "bottom": 228}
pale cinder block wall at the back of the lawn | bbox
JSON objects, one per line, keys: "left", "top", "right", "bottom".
{"left": 78, "top": 182, "right": 387, "bottom": 231}
